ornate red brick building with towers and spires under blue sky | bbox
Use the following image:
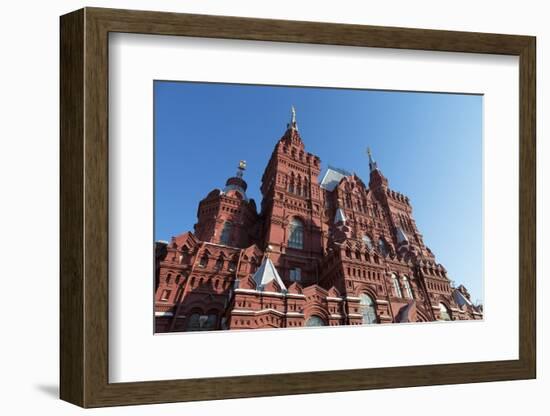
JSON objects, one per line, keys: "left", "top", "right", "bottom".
{"left": 155, "top": 109, "right": 483, "bottom": 332}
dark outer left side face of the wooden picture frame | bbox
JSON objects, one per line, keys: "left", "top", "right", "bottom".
{"left": 59, "top": 10, "right": 86, "bottom": 406}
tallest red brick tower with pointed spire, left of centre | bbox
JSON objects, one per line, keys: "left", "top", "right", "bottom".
{"left": 260, "top": 107, "right": 323, "bottom": 285}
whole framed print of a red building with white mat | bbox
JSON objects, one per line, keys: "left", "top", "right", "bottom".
{"left": 60, "top": 8, "right": 536, "bottom": 407}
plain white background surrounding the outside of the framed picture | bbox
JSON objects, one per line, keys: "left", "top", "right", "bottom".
{"left": 0, "top": 0, "right": 550, "bottom": 416}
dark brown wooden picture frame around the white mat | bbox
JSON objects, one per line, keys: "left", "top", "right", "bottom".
{"left": 60, "top": 8, "right": 536, "bottom": 407}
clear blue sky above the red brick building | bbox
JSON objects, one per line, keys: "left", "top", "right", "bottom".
{"left": 154, "top": 81, "right": 483, "bottom": 301}
